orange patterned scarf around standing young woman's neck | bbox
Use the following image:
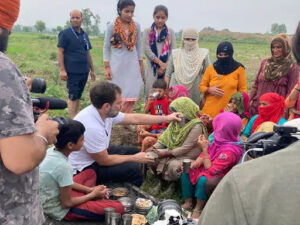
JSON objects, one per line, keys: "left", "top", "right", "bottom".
{"left": 110, "top": 17, "right": 137, "bottom": 51}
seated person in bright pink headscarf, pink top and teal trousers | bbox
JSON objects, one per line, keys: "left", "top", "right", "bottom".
{"left": 181, "top": 112, "right": 243, "bottom": 218}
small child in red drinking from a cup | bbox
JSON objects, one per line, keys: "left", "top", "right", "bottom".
{"left": 138, "top": 79, "right": 169, "bottom": 151}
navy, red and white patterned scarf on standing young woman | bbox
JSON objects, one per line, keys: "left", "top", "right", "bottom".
{"left": 149, "top": 23, "right": 170, "bottom": 76}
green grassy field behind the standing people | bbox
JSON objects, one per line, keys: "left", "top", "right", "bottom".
{"left": 7, "top": 33, "right": 270, "bottom": 116}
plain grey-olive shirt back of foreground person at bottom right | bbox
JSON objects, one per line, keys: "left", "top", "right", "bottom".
{"left": 198, "top": 141, "right": 300, "bottom": 225}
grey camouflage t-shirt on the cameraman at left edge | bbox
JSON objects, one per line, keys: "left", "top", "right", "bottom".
{"left": 0, "top": 52, "right": 44, "bottom": 225}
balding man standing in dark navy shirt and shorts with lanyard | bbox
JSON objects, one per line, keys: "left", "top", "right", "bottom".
{"left": 57, "top": 10, "right": 96, "bottom": 118}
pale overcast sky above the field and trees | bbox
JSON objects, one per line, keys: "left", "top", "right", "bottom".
{"left": 16, "top": 0, "right": 300, "bottom": 34}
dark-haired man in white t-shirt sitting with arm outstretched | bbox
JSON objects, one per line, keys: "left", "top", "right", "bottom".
{"left": 69, "top": 82, "right": 180, "bottom": 186}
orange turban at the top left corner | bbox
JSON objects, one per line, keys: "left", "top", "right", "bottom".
{"left": 0, "top": 0, "right": 20, "bottom": 30}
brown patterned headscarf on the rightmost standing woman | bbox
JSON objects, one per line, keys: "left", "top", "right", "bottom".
{"left": 264, "top": 34, "right": 293, "bottom": 81}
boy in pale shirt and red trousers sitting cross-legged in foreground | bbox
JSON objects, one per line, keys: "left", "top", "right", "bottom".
{"left": 40, "top": 119, "right": 124, "bottom": 221}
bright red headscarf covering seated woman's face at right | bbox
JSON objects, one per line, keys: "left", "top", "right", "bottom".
{"left": 251, "top": 93, "right": 285, "bottom": 134}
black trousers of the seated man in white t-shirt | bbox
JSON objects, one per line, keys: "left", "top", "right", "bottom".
{"left": 85, "top": 146, "right": 143, "bottom": 187}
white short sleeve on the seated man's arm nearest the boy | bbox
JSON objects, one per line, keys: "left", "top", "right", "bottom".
{"left": 83, "top": 127, "right": 108, "bottom": 153}
